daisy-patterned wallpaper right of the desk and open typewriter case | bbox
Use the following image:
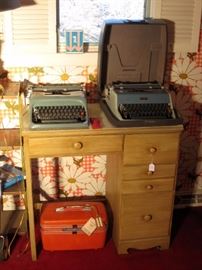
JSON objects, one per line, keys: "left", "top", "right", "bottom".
{"left": 166, "top": 22, "right": 202, "bottom": 207}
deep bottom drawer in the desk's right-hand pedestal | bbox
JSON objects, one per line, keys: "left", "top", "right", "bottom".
{"left": 120, "top": 192, "right": 173, "bottom": 240}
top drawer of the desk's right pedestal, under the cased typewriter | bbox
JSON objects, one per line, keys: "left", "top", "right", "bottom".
{"left": 124, "top": 133, "right": 178, "bottom": 165}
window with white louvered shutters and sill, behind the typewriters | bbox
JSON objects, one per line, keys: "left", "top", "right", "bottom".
{"left": 0, "top": 0, "right": 202, "bottom": 67}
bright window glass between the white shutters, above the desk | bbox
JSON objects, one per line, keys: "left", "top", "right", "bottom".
{"left": 59, "top": 0, "right": 144, "bottom": 43}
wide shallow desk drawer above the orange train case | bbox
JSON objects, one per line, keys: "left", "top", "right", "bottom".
{"left": 29, "top": 135, "right": 122, "bottom": 157}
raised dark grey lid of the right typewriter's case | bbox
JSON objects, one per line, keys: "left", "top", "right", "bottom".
{"left": 98, "top": 19, "right": 167, "bottom": 94}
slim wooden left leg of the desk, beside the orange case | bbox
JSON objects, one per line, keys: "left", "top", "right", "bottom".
{"left": 24, "top": 142, "right": 37, "bottom": 261}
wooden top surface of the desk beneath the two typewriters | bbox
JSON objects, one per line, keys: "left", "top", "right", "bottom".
{"left": 21, "top": 103, "right": 182, "bottom": 138}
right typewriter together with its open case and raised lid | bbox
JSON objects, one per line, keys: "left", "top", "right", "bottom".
{"left": 98, "top": 19, "right": 182, "bottom": 126}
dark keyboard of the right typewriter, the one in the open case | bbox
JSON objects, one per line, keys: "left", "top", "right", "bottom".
{"left": 119, "top": 103, "right": 172, "bottom": 119}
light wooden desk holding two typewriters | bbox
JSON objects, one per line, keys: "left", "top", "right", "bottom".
{"left": 22, "top": 104, "right": 182, "bottom": 260}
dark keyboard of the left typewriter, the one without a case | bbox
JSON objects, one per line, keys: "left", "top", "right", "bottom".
{"left": 32, "top": 105, "right": 86, "bottom": 124}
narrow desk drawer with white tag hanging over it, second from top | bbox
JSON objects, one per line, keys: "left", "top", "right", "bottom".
{"left": 123, "top": 164, "right": 176, "bottom": 180}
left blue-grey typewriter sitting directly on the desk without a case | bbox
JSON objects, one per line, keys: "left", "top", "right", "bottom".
{"left": 27, "top": 83, "right": 89, "bottom": 129}
